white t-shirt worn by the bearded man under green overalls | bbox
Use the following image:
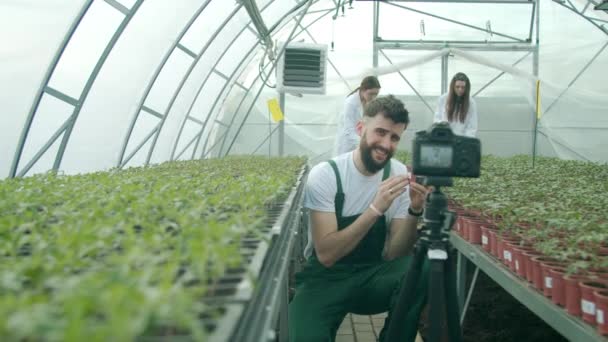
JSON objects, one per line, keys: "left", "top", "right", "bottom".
{"left": 303, "top": 152, "right": 410, "bottom": 258}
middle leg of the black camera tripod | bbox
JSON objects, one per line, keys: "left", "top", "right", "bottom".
{"left": 429, "top": 260, "right": 445, "bottom": 342}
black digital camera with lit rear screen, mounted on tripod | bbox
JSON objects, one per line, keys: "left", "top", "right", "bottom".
{"left": 412, "top": 122, "right": 481, "bottom": 178}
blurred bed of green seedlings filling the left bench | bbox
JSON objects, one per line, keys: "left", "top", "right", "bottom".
{"left": 0, "top": 156, "right": 305, "bottom": 341}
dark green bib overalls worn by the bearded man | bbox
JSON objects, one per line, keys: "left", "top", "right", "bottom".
{"left": 289, "top": 160, "right": 428, "bottom": 342}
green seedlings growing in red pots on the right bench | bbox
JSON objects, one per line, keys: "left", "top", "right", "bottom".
{"left": 434, "top": 156, "right": 608, "bottom": 268}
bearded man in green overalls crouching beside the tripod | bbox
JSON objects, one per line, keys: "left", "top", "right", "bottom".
{"left": 289, "top": 95, "right": 428, "bottom": 342}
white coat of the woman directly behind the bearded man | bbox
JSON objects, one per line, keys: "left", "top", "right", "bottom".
{"left": 334, "top": 91, "right": 363, "bottom": 156}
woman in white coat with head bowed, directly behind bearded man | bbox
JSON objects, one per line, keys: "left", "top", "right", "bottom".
{"left": 334, "top": 76, "right": 380, "bottom": 155}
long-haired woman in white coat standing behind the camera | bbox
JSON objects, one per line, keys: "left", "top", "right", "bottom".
{"left": 433, "top": 72, "right": 477, "bottom": 137}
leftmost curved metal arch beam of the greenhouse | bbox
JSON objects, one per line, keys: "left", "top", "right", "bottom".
{"left": 8, "top": 0, "right": 93, "bottom": 178}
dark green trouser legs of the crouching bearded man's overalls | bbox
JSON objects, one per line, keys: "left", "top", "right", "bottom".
{"left": 289, "top": 256, "right": 428, "bottom": 342}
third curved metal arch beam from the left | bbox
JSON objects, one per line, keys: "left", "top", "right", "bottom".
{"left": 116, "top": 0, "right": 211, "bottom": 167}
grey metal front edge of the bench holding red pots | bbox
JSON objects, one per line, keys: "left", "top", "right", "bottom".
{"left": 450, "top": 232, "right": 608, "bottom": 342}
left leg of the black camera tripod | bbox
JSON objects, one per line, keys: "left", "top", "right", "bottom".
{"left": 380, "top": 243, "right": 427, "bottom": 342}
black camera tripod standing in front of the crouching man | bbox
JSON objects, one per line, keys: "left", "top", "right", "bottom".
{"left": 387, "top": 177, "right": 462, "bottom": 342}
